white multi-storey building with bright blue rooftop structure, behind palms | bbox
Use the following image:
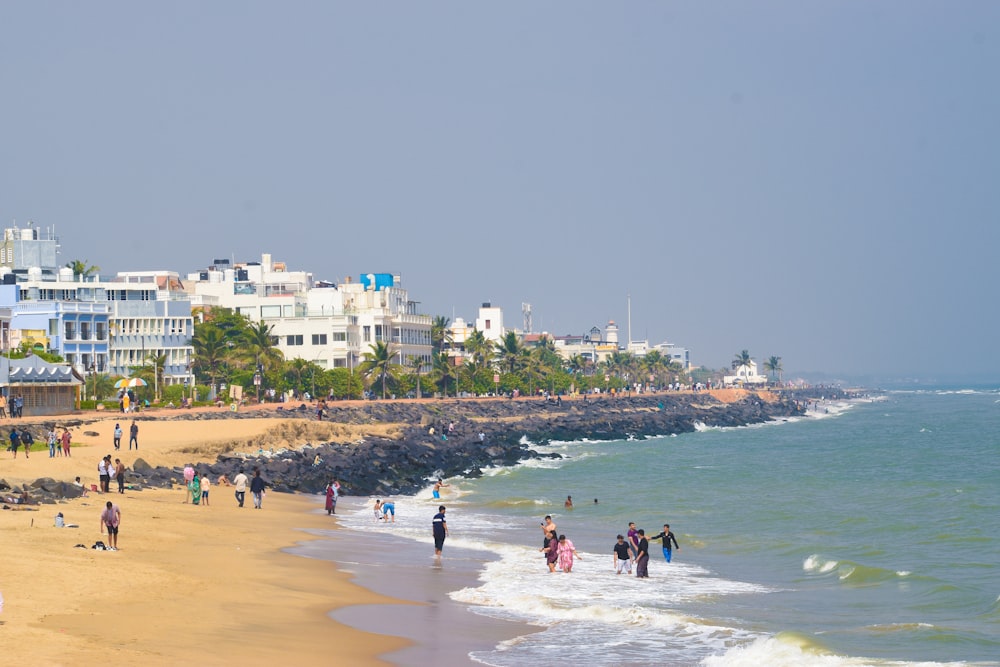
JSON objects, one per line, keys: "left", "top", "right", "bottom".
{"left": 188, "top": 254, "right": 431, "bottom": 368}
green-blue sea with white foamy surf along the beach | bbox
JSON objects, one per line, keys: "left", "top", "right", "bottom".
{"left": 296, "top": 387, "right": 1000, "bottom": 667}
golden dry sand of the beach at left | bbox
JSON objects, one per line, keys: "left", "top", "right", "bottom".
{"left": 0, "top": 415, "right": 410, "bottom": 666}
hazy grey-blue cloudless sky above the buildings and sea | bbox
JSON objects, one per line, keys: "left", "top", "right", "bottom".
{"left": 0, "top": 0, "right": 1000, "bottom": 381}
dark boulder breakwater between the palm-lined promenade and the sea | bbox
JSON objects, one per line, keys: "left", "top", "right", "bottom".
{"left": 19, "top": 391, "right": 838, "bottom": 502}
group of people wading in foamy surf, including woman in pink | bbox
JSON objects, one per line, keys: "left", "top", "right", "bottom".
{"left": 539, "top": 515, "right": 680, "bottom": 579}
